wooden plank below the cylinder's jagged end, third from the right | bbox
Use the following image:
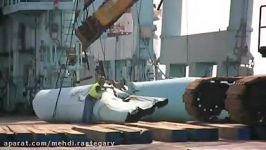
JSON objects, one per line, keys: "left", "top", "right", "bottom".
{"left": 127, "top": 122, "right": 188, "bottom": 142}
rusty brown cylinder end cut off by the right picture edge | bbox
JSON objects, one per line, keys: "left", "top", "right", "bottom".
{"left": 225, "top": 76, "right": 266, "bottom": 125}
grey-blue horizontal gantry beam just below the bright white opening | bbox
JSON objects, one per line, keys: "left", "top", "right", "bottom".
{"left": 160, "top": 31, "right": 235, "bottom": 64}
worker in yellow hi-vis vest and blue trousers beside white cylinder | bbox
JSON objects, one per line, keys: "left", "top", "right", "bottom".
{"left": 82, "top": 76, "right": 105, "bottom": 123}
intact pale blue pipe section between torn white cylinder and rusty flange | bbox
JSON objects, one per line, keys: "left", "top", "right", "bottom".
{"left": 129, "top": 77, "right": 199, "bottom": 121}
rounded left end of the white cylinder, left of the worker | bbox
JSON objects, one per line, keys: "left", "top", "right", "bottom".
{"left": 33, "top": 85, "right": 90, "bottom": 122}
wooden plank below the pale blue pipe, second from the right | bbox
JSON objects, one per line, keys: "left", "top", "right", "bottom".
{"left": 160, "top": 122, "right": 219, "bottom": 141}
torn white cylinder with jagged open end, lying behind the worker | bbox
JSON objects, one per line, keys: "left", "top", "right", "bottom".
{"left": 33, "top": 85, "right": 167, "bottom": 123}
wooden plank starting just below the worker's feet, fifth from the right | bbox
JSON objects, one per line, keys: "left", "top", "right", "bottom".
{"left": 72, "top": 125, "right": 123, "bottom": 145}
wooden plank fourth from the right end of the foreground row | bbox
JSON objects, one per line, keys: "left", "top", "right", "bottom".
{"left": 100, "top": 124, "right": 152, "bottom": 144}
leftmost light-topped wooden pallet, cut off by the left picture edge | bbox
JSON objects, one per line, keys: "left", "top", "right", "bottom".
{"left": 0, "top": 125, "right": 87, "bottom": 146}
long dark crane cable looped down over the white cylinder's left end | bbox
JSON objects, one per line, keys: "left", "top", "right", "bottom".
{"left": 52, "top": 0, "right": 78, "bottom": 120}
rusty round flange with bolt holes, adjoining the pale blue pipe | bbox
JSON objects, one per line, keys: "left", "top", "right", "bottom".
{"left": 183, "top": 77, "right": 240, "bottom": 121}
